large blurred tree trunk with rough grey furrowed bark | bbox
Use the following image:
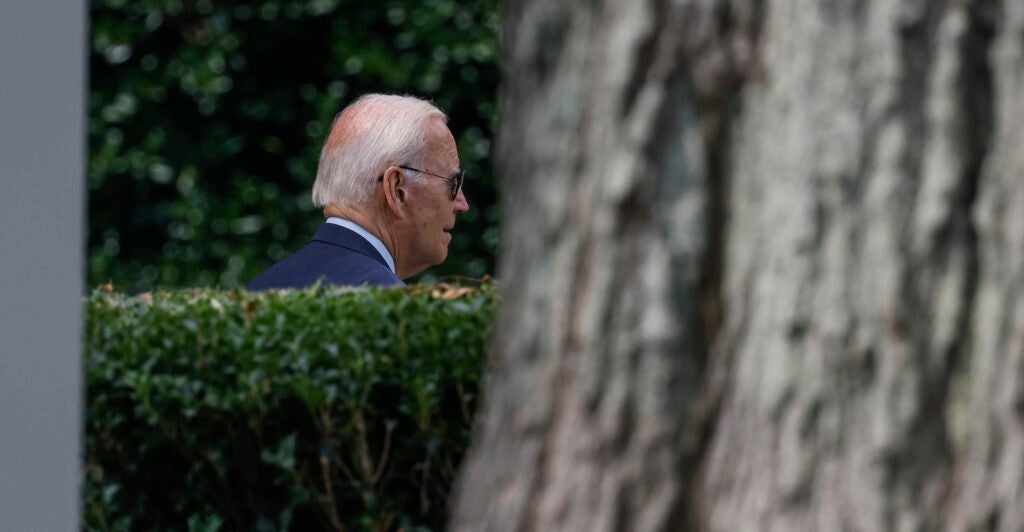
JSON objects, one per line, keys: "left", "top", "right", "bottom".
{"left": 452, "top": 0, "right": 1024, "bottom": 531}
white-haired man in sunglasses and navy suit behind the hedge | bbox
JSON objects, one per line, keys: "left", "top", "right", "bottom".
{"left": 246, "top": 94, "right": 469, "bottom": 291}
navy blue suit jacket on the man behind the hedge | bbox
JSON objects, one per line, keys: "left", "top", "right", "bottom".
{"left": 246, "top": 223, "right": 406, "bottom": 291}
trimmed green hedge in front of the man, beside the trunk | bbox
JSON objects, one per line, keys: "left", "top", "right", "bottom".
{"left": 83, "top": 283, "right": 497, "bottom": 531}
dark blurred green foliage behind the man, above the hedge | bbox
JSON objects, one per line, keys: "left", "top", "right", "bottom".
{"left": 88, "top": 0, "right": 501, "bottom": 292}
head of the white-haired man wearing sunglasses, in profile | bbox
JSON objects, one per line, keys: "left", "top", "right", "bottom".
{"left": 312, "top": 94, "right": 469, "bottom": 278}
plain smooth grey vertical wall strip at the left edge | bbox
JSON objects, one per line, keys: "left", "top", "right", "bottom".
{"left": 0, "top": 0, "right": 87, "bottom": 531}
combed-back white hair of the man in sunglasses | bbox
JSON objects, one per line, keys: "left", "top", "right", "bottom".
{"left": 312, "top": 94, "right": 447, "bottom": 207}
